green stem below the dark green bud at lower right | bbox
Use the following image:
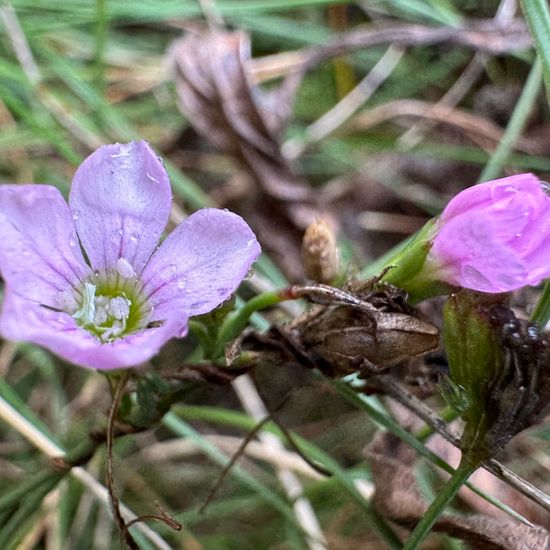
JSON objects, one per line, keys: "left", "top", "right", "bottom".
{"left": 403, "top": 455, "right": 479, "bottom": 550}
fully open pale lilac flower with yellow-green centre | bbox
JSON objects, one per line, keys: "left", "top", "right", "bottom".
{"left": 0, "top": 141, "right": 260, "bottom": 369}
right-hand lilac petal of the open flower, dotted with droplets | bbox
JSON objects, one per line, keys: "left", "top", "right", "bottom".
{"left": 142, "top": 208, "right": 260, "bottom": 319}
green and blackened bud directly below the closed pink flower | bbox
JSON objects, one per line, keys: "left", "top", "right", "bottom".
{"left": 443, "top": 290, "right": 550, "bottom": 459}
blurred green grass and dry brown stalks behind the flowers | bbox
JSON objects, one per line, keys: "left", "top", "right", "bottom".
{"left": 0, "top": 0, "right": 550, "bottom": 550}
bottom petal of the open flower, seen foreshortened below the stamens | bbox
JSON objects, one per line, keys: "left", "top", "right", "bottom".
{"left": 0, "top": 291, "right": 187, "bottom": 370}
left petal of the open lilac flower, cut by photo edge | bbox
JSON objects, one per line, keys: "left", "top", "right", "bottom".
{"left": 0, "top": 185, "right": 90, "bottom": 307}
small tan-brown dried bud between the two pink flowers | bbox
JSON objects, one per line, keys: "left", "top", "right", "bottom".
{"left": 302, "top": 218, "right": 340, "bottom": 284}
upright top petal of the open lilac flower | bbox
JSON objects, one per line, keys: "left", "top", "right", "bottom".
{"left": 69, "top": 141, "right": 172, "bottom": 275}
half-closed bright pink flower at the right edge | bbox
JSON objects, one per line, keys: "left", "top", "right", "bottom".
{"left": 427, "top": 174, "right": 550, "bottom": 293}
